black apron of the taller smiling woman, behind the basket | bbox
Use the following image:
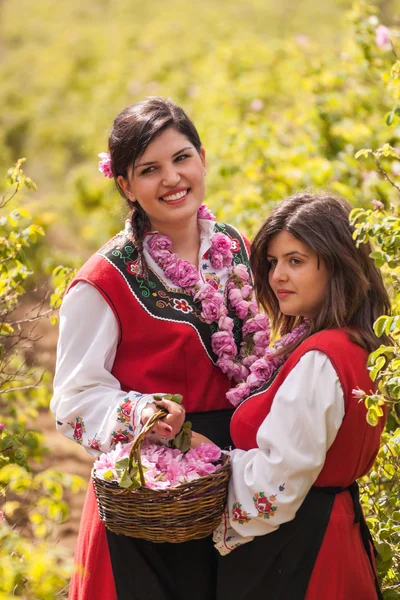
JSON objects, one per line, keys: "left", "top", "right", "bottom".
{"left": 107, "top": 410, "right": 233, "bottom": 600}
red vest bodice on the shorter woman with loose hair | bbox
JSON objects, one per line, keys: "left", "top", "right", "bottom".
{"left": 231, "top": 330, "right": 385, "bottom": 487}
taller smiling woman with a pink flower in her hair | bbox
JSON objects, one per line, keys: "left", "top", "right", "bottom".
{"left": 51, "top": 98, "right": 268, "bottom": 600}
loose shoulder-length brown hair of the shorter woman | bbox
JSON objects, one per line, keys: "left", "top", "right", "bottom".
{"left": 251, "top": 192, "right": 390, "bottom": 352}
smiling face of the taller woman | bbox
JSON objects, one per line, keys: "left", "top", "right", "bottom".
{"left": 118, "top": 128, "right": 205, "bottom": 230}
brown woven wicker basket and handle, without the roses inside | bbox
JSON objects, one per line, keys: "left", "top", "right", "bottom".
{"left": 92, "top": 409, "right": 230, "bottom": 543}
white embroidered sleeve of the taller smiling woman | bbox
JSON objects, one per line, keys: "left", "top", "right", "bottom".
{"left": 50, "top": 282, "right": 163, "bottom": 456}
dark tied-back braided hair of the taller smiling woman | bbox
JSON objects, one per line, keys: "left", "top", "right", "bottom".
{"left": 108, "top": 96, "right": 201, "bottom": 276}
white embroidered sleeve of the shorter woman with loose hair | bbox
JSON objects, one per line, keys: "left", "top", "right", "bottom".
{"left": 214, "top": 351, "right": 344, "bottom": 555}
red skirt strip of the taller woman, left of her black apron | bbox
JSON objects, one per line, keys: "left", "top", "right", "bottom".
{"left": 68, "top": 482, "right": 117, "bottom": 600}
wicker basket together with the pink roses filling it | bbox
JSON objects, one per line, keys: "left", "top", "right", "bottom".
{"left": 92, "top": 395, "right": 230, "bottom": 543}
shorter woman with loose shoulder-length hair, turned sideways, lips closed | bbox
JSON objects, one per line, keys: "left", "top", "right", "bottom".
{"left": 214, "top": 193, "right": 390, "bottom": 600}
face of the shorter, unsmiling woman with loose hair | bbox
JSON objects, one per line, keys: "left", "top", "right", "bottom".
{"left": 267, "top": 231, "right": 329, "bottom": 319}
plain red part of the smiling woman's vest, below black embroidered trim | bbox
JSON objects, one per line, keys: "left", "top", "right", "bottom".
{"left": 69, "top": 255, "right": 232, "bottom": 412}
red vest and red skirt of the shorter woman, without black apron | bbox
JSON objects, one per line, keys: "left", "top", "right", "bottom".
{"left": 231, "top": 330, "right": 384, "bottom": 600}
